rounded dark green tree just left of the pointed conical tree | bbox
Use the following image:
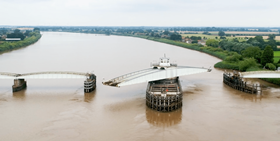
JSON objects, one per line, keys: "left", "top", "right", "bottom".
{"left": 241, "top": 47, "right": 262, "bottom": 63}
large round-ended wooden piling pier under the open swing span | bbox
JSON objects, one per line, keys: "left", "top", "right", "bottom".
{"left": 146, "top": 77, "right": 183, "bottom": 112}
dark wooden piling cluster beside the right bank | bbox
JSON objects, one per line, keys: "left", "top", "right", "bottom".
{"left": 223, "top": 72, "right": 261, "bottom": 94}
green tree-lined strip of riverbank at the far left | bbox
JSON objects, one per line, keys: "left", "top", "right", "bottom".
{"left": 0, "top": 32, "right": 42, "bottom": 54}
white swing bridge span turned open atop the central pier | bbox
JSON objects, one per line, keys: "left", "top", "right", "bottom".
{"left": 102, "top": 66, "right": 211, "bottom": 87}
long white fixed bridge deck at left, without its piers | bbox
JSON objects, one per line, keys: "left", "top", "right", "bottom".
{"left": 0, "top": 72, "right": 90, "bottom": 79}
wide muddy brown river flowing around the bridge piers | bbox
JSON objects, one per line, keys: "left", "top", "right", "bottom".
{"left": 0, "top": 32, "right": 280, "bottom": 141}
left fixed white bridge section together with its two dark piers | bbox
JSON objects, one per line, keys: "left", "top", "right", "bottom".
{"left": 0, "top": 71, "right": 96, "bottom": 92}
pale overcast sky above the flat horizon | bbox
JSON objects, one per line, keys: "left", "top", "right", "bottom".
{"left": 0, "top": 0, "right": 280, "bottom": 27}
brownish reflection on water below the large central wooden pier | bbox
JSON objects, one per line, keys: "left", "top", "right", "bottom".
{"left": 146, "top": 107, "right": 182, "bottom": 127}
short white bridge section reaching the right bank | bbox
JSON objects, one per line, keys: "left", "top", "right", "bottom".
{"left": 239, "top": 71, "right": 280, "bottom": 78}
